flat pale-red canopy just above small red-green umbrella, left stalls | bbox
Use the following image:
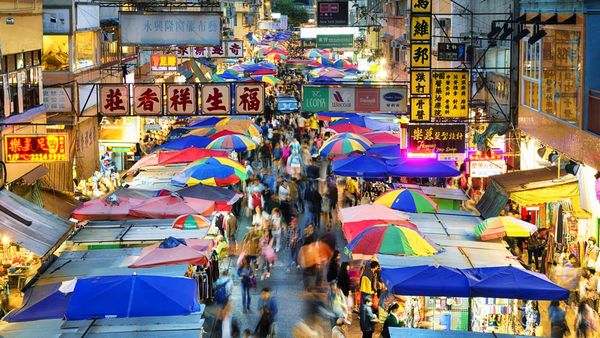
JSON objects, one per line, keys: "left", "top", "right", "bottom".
{"left": 129, "top": 195, "right": 215, "bottom": 218}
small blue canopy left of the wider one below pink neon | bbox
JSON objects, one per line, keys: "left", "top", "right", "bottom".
{"left": 331, "top": 155, "right": 387, "bottom": 178}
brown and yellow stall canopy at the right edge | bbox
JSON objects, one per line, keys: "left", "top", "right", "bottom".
{"left": 477, "top": 167, "right": 588, "bottom": 218}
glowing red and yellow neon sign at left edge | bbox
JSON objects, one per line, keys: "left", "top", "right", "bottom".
{"left": 4, "top": 134, "right": 69, "bottom": 163}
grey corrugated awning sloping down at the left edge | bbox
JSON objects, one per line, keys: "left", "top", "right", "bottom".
{"left": 0, "top": 190, "right": 73, "bottom": 256}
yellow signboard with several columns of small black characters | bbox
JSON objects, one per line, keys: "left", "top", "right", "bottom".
{"left": 431, "top": 71, "right": 469, "bottom": 118}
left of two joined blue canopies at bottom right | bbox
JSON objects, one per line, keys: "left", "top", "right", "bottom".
{"left": 381, "top": 265, "right": 471, "bottom": 297}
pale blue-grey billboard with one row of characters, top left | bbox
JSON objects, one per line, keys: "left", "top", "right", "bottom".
{"left": 119, "top": 12, "right": 221, "bottom": 46}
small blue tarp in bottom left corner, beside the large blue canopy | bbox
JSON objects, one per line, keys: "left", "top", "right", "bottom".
{"left": 3, "top": 283, "right": 72, "bottom": 322}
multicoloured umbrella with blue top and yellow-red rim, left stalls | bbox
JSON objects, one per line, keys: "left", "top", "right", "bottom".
{"left": 171, "top": 157, "right": 248, "bottom": 186}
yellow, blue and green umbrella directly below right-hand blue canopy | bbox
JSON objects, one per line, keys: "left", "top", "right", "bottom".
{"left": 374, "top": 189, "right": 439, "bottom": 213}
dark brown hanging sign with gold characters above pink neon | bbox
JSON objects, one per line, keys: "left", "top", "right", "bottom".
{"left": 407, "top": 124, "right": 466, "bottom": 154}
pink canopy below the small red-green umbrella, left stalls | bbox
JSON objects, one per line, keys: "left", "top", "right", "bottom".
{"left": 129, "top": 239, "right": 214, "bottom": 268}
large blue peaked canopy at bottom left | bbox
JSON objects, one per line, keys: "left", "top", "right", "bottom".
{"left": 65, "top": 275, "right": 200, "bottom": 320}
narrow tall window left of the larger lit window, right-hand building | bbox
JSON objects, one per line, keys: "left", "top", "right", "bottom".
{"left": 521, "top": 39, "right": 542, "bottom": 110}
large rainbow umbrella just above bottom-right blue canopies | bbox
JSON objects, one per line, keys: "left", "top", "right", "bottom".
{"left": 346, "top": 224, "right": 440, "bottom": 256}
